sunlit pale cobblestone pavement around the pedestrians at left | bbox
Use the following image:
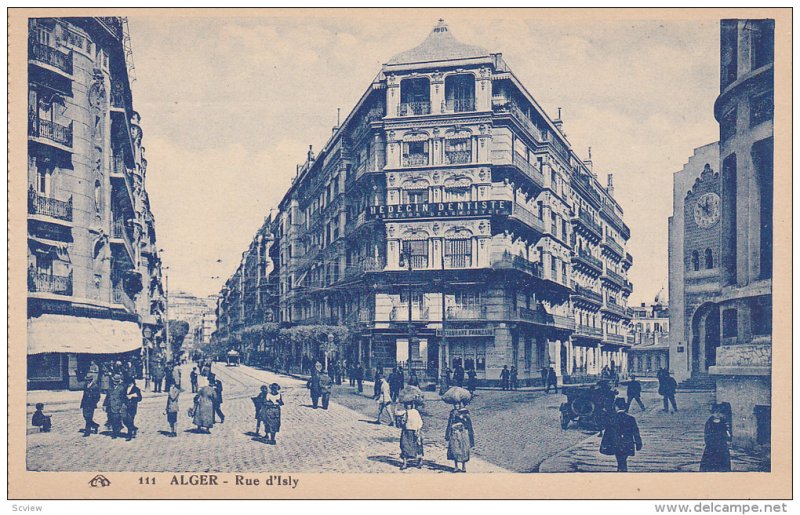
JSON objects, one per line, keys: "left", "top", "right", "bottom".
{"left": 27, "top": 364, "right": 504, "bottom": 474}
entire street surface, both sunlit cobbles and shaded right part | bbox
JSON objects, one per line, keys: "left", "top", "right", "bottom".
{"left": 27, "top": 363, "right": 768, "bottom": 474}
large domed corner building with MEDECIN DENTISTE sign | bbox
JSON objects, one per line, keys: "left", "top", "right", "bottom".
{"left": 219, "top": 21, "right": 633, "bottom": 383}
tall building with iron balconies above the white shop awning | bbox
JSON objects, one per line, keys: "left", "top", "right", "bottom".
{"left": 28, "top": 18, "right": 164, "bottom": 388}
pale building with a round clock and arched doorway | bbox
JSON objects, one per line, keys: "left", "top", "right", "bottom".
{"left": 669, "top": 142, "right": 720, "bottom": 387}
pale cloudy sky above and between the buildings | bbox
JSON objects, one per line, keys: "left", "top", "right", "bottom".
{"left": 129, "top": 10, "right": 719, "bottom": 304}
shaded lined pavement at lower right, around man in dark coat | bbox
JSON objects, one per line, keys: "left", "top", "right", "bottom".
{"left": 539, "top": 391, "right": 769, "bottom": 472}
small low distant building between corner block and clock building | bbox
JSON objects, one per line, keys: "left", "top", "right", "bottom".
{"left": 628, "top": 289, "right": 670, "bottom": 376}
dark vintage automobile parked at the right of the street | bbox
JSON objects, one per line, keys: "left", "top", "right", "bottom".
{"left": 560, "top": 380, "right": 618, "bottom": 431}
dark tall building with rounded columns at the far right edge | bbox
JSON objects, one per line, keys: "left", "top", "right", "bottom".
{"left": 709, "top": 20, "right": 775, "bottom": 445}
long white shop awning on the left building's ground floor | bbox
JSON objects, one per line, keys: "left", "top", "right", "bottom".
{"left": 28, "top": 315, "right": 142, "bottom": 354}
